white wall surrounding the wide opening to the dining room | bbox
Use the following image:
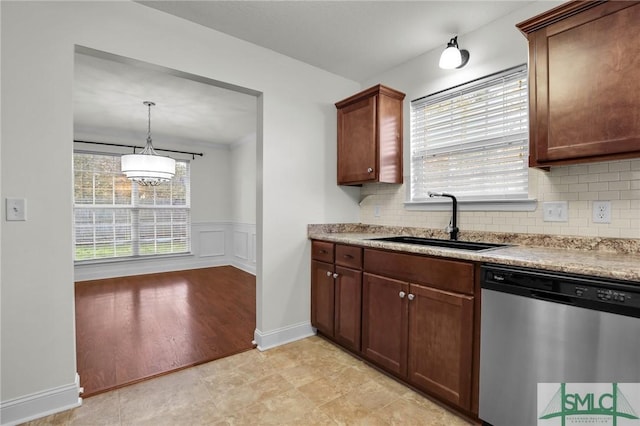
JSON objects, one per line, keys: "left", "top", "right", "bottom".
{"left": 0, "top": 2, "right": 360, "bottom": 423}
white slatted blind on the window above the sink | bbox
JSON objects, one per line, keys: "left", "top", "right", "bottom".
{"left": 409, "top": 65, "right": 529, "bottom": 202}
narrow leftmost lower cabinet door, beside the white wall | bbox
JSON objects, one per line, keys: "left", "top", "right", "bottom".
{"left": 311, "top": 260, "right": 335, "bottom": 337}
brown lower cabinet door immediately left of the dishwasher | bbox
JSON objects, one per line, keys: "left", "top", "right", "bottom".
{"left": 408, "top": 285, "right": 473, "bottom": 410}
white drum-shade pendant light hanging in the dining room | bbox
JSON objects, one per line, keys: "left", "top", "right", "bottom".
{"left": 120, "top": 101, "right": 176, "bottom": 186}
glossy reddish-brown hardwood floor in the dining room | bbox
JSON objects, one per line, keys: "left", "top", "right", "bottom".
{"left": 75, "top": 266, "right": 256, "bottom": 397}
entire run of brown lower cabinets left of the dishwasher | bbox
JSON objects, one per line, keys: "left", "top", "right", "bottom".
{"left": 311, "top": 243, "right": 479, "bottom": 417}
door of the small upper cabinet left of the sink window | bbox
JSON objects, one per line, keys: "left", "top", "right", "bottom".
{"left": 338, "top": 96, "right": 378, "bottom": 184}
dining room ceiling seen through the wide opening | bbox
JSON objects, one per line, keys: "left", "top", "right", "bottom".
{"left": 73, "top": 52, "right": 257, "bottom": 149}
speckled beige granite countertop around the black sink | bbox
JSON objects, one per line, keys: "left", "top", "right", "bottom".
{"left": 308, "top": 224, "right": 640, "bottom": 285}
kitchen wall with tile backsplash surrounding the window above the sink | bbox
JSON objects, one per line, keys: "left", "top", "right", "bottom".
{"left": 360, "top": 1, "right": 640, "bottom": 238}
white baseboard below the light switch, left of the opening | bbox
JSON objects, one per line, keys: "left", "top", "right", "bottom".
{"left": 0, "top": 373, "right": 82, "bottom": 426}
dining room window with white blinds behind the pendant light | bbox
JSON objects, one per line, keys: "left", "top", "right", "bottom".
{"left": 73, "top": 152, "right": 191, "bottom": 261}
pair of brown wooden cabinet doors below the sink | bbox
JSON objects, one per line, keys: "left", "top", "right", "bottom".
{"left": 362, "top": 273, "right": 473, "bottom": 410}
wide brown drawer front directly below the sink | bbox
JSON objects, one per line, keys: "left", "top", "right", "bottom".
{"left": 364, "top": 249, "right": 474, "bottom": 294}
